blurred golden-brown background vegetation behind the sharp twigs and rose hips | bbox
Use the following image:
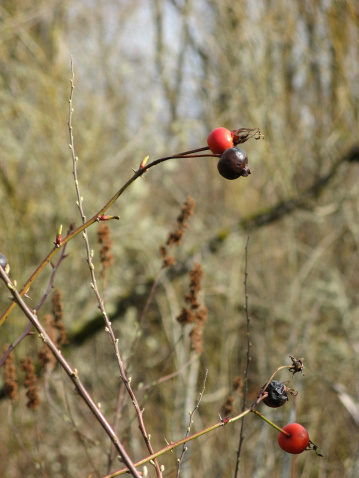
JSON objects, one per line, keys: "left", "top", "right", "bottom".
{"left": 0, "top": 0, "right": 359, "bottom": 478}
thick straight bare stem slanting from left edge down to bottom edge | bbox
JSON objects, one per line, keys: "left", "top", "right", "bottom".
{"left": 0, "top": 266, "right": 140, "bottom": 478}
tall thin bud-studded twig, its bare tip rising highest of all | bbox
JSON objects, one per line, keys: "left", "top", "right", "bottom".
{"left": 68, "top": 62, "right": 162, "bottom": 478}
